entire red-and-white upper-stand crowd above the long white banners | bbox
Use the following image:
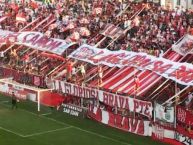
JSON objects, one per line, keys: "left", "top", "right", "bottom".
{"left": 0, "top": 0, "right": 193, "bottom": 56}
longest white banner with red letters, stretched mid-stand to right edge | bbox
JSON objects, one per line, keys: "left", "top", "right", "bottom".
{"left": 69, "top": 44, "right": 193, "bottom": 86}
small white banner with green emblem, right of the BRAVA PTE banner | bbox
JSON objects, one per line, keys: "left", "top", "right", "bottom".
{"left": 154, "top": 103, "right": 174, "bottom": 123}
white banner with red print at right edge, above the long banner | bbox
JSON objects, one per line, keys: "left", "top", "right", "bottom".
{"left": 172, "top": 34, "right": 193, "bottom": 56}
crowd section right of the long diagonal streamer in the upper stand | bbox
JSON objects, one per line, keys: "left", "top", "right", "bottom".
{"left": 100, "top": 3, "right": 193, "bottom": 56}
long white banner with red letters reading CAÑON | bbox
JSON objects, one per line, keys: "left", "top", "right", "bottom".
{"left": 0, "top": 32, "right": 75, "bottom": 55}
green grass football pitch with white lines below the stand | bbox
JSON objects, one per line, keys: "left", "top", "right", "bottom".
{"left": 0, "top": 96, "right": 167, "bottom": 145}
